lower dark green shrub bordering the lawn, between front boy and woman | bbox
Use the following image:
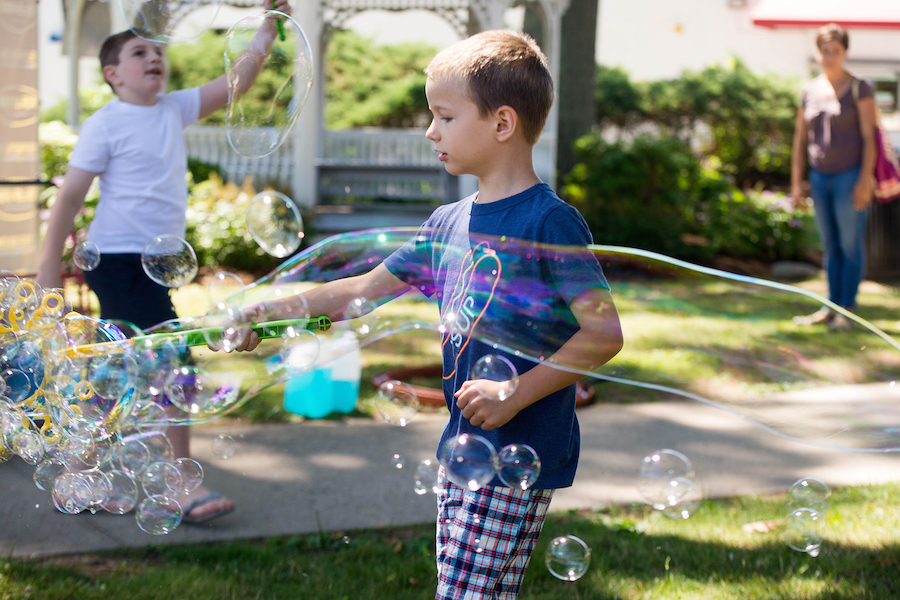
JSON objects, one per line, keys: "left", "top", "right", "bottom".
{"left": 562, "top": 133, "right": 817, "bottom": 262}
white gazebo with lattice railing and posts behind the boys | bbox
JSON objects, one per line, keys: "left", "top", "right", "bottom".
{"left": 63, "top": 0, "right": 569, "bottom": 228}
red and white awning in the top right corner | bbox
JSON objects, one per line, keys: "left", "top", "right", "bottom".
{"left": 751, "top": 0, "right": 900, "bottom": 29}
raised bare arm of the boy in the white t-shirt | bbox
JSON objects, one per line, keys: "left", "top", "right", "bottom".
{"left": 200, "top": 0, "right": 291, "bottom": 119}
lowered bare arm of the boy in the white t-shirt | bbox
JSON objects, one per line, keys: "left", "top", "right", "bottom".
{"left": 36, "top": 166, "right": 98, "bottom": 288}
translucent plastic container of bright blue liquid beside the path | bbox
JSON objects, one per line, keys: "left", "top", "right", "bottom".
{"left": 284, "top": 333, "right": 362, "bottom": 419}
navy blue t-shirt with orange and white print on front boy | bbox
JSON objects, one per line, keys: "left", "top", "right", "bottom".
{"left": 384, "top": 183, "right": 609, "bottom": 489}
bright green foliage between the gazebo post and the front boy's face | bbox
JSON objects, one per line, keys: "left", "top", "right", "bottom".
{"left": 325, "top": 31, "right": 437, "bottom": 129}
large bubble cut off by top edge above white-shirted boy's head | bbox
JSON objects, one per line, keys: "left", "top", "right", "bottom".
{"left": 117, "top": 0, "right": 221, "bottom": 44}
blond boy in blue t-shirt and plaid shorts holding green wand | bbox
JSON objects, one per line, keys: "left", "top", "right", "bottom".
{"left": 236, "top": 31, "right": 622, "bottom": 600}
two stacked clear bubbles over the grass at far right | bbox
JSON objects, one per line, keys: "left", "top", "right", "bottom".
{"left": 784, "top": 477, "right": 831, "bottom": 557}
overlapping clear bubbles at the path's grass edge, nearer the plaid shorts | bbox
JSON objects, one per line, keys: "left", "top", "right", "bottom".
{"left": 638, "top": 448, "right": 700, "bottom": 519}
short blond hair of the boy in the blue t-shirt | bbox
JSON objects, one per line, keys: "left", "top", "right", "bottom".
{"left": 425, "top": 30, "right": 554, "bottom": 145}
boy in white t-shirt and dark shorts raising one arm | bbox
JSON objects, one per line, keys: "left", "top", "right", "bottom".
{"left": 37, "top": 0, "right": 291, "bottom": 523}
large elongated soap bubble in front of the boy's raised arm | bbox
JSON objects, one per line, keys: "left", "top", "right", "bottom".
{"left": 225, "top": 11, "right": 313, "bottom": 158}
